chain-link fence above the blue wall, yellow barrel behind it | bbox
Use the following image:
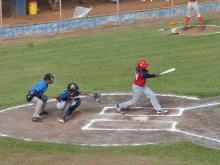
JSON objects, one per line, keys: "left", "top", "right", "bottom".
{"left": 0, "top": 0, "right": 220, "bottom": 27}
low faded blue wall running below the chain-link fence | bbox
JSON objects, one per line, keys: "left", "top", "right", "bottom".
{"left": 0, "top": 2, "right": 220, "bottom": 39}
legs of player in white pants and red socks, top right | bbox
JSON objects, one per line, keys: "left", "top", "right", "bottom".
{"left": 183, "top": 0, "right": 205, "bottom": 32}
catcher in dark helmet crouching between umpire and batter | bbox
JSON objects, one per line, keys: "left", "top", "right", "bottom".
{"left": 57, "top": 83, "right": 81, "bottom": 123}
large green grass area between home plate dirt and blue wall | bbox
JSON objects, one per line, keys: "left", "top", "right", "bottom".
{"left": 0, "top": 20, "right": 220, "bottom": 108}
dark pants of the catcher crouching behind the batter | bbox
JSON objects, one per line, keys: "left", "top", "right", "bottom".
{"left": 60, "top": 98, "right": 81, "bottom": 119}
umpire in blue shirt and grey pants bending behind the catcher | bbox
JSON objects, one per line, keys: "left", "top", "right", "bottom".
{"left": 26, "top": 73, "right": 55, "bottom": 122}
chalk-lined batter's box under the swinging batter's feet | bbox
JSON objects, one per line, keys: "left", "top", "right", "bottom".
{"left": 99, "top": 107, "right": 184, "bottom": 116}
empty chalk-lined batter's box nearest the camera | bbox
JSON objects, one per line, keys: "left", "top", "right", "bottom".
{"left": 82, "top": 119, "right": 176, "bottom": 131}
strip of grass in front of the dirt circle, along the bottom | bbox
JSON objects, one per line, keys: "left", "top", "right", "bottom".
{"left": 0, "top": 138, "right": 220, "bottom": 165}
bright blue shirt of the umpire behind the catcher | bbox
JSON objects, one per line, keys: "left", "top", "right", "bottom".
{"left": 30, "top": 80, "right": 48, "bottom": 97}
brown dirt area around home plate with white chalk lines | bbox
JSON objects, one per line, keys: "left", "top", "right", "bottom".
{"left": 0, "top": 93, "right": 220, "bottom": 149}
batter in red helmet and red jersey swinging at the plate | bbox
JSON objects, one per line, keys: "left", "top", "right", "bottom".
{"left": 115, "top": 60, "right": 167, "bottom": 113}
